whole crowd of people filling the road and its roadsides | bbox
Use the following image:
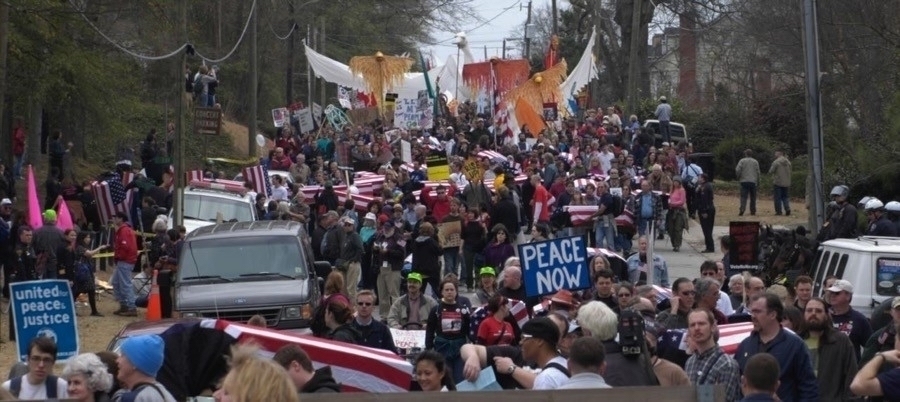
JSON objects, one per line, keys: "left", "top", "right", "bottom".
{"left": 0, "top": 83, "right": 900, "bottom": 401}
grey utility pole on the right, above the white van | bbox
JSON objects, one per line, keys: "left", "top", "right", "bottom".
{"left": 803, "top": 0, "right": 825, "bottom": 236}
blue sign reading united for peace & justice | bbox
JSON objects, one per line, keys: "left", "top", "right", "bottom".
{"left": 9, "top": 279, "right": 78, "bottom": 362}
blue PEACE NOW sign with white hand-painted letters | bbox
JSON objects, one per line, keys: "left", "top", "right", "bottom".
{"left": 519, "top": 236, "right": 591, "bottom": 297}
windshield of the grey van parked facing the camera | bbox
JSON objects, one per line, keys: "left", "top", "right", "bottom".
{"left": 178, "top": 235, "right": 308, "bottom": 281}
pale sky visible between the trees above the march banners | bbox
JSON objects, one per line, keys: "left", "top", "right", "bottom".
{"left": 426, "top": 0, "right": 552, "bottom": 63}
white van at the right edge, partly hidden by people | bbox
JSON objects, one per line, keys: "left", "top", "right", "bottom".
{"left": 812, "top": 236, "right": 900, "bottom": 316}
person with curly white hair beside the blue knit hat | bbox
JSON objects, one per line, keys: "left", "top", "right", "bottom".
{"left": 62, "top": 353, "right": 113, "bottom": 402}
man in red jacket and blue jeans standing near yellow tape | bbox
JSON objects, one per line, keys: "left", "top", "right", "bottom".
{"left": 112, "top": 212, "right": 138, "bottom": 317}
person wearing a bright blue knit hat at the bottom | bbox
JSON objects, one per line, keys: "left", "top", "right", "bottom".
{"left": 113, "top": 335, "right": 175, "bottom": 402}
